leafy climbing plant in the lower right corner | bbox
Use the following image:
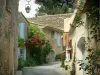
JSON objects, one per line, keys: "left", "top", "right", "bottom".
{"left": 80, "top": 48, "right": 100, "bottom": 75}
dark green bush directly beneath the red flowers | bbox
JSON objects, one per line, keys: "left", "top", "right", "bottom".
{"left": 25, "top": 40, "right": 52, "bottom": 65}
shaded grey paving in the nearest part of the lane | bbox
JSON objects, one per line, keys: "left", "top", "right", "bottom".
{"left": 23, "top": 68, "right": 61, "bottom": 75}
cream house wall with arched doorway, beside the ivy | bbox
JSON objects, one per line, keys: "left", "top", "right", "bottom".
{"left": 66, "top": 12, "right": 86, "bottom": 75}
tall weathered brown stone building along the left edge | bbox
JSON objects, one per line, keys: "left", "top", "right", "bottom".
{"left": 0, "top": 0, "right": 19, "bottom": 75}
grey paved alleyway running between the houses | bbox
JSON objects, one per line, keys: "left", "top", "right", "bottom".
{"left": 23, "top": 62, "right": 68, "bottom": 75}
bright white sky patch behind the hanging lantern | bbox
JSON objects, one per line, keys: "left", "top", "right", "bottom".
{"left": 18, "top": 0, "right": 39, "bottom": 18}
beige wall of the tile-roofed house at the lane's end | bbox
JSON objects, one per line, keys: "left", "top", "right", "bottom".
{"left": 43, "top": 28, "right": 62, "bottom": 55}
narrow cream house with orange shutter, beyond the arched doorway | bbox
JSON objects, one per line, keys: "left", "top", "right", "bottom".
{"left": 63, "top": 10, "right": 77, "bottom": 61}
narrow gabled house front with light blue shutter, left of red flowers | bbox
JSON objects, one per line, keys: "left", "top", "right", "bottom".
{"left": 18, "top": 12, "right": 29, "bottom": 60}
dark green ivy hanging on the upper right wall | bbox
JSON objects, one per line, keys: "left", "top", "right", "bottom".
{"left": 87, "top": 7, "right": 100, "bottom": 41}
